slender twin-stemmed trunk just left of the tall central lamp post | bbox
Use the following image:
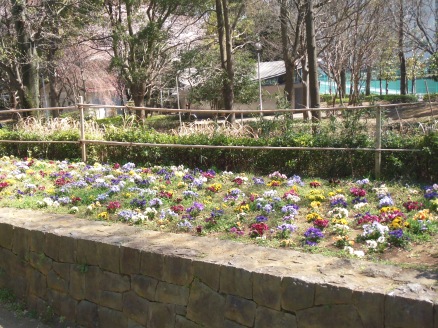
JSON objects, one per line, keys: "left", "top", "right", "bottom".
{"left": 216, "top": 0, "right": 236, "bottom": 122}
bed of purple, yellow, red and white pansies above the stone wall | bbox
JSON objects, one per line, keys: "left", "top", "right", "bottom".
{"left": 0, "top": 157, "right": 438, "bottom": 265}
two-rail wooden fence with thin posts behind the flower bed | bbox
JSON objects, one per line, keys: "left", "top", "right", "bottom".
{"left": 0, "top": 99, "right": 434, "bottom": 179}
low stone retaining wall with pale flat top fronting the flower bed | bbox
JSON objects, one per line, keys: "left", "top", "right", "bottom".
{"left": 0, "top": 208, "right": 438, "bottom": 328}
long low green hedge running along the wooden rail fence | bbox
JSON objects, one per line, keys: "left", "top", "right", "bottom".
{"left": 0, "top": 113, "right": 438, "bottom": 181}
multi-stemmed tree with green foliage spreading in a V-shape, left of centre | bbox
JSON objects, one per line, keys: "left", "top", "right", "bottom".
{"left": 102, "top": 0, "right": 205, "bottom": 116}
